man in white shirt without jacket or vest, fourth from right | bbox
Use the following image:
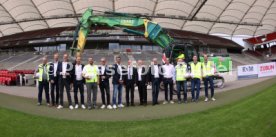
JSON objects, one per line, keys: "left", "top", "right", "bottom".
{"left": 162, "top": 59, "right": 175, "bottom": 104}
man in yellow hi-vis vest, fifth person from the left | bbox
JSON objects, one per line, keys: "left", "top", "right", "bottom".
{"left": 82, "top": 57, "right": 99, "bottom": 110}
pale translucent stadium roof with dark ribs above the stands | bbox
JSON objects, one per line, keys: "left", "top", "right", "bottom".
{"left": 0, "top": 0, "right": 276, "bottom": 37}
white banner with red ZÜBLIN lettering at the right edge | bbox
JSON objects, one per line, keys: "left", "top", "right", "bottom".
{"left": 258, "top": 62, "right": 276, "bottom": 78}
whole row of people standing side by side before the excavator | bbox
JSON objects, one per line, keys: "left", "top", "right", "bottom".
{"left": 37, "top": 54, "right": 215, "bottom": 109}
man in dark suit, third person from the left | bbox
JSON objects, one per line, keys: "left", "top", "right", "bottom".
{"left": 57, "top": 53, "right": 74, "bottom": 109}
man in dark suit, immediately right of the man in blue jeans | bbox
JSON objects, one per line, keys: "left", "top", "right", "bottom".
{"left": 124, "top": 60, "right": 137, "bottom": 107}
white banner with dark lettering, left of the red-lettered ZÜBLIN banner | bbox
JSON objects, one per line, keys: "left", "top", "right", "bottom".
{"left": 238, "top": 64, "right": 258, "bottom": 79}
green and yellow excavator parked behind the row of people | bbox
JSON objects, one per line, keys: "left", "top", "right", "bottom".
{"left": 71, "top": 8, "right": 231, "bottom": 87}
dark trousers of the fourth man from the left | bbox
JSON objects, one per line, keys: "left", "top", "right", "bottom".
{"left": 74, "top": 80, "right": 84, "bottom": 105}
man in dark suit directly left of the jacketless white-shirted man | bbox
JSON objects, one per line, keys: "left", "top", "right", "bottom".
{"left": 149, "top": 58, "right": 163, "bottom": 105}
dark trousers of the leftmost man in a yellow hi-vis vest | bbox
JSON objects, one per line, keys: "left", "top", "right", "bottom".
{"left": 38, "top": 81, "right": 50, "bottom": 103}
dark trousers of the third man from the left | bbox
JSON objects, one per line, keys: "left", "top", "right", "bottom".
{"left": 59, "top": 78, "right": 72, "bottom": 106}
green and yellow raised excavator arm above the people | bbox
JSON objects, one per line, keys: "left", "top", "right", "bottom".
{"left": 71, "top": 8, "right": 173, "bottom": 55}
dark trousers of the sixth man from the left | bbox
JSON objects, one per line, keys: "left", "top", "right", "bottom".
{"left": 100, "top": 81, "right": 110, "bottom": 105}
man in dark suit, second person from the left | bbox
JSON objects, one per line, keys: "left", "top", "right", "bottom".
{"left": 49, "top": 53, "right": 61, "bottom": 107}
